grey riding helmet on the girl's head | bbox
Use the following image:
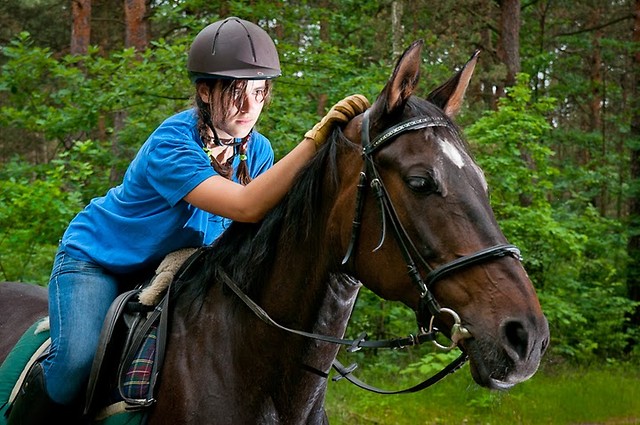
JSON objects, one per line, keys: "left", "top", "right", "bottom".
{"left": 187, "top": 17, "right": 280, "bottom": 82}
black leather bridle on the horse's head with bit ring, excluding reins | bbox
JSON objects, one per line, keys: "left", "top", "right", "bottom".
{"left": 342, "top": 110, "right": 521, "bottom": 336}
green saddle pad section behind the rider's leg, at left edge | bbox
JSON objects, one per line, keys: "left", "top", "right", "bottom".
{"left": 0, "top": 319, "right": 49, "bottom": 419}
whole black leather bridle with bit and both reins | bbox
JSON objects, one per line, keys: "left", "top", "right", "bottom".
{"left": 218, "top": 110, "right": 521, "bottom": 394}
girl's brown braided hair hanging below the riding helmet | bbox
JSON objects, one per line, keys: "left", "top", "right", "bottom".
{"left": 195, "top": 79, "right": 271, "bottom": 185}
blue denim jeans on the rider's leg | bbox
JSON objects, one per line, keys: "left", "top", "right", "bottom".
{"left": 42, "top": 247, "right": 120, "bottom": 405}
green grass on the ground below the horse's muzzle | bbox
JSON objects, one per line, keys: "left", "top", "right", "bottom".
{"left": 326, "top": 358, "right": 640, "bottom": 425}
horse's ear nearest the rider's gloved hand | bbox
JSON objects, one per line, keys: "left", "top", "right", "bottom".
{"left": 371, "top": 40, "right": 424, "bottom": 116}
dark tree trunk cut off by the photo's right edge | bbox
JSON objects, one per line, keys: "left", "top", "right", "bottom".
{"left": 627, "top": 0, "right": 640, "bottom": 338}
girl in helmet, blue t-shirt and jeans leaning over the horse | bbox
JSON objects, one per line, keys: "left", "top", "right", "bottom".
{"left": 8, "top": 17, "right": 368, "bottom": 425}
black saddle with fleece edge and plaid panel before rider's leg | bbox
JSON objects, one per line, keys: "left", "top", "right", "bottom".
{"left": 84, "top": 248, "right": 198, "bottom": 419}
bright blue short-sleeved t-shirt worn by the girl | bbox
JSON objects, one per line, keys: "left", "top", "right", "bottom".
{"left": 61, "top": 109, "right": 274, "bottom": 273}
